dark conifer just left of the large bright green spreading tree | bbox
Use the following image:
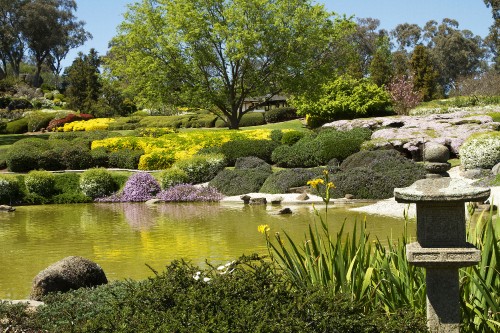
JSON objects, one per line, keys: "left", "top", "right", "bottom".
{"left": 65, "top": 49, "right": 102, "bottom": 113}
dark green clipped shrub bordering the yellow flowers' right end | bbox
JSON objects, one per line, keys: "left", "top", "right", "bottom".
{"left": 221, "top": 139, "right": 279, "bottom": 166}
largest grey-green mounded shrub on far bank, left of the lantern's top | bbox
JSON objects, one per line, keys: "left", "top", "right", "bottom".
{"left": 332, "top": 150, "right": 426, "bottom": 199}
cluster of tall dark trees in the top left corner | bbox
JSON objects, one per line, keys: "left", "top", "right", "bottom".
{"left": 0, "top": 0, "right": 92, "bottom": 87}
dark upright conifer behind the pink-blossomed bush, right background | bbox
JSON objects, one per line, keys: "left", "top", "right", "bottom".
{"left": 410, "top": 45, "right": 438, "bottom": 101}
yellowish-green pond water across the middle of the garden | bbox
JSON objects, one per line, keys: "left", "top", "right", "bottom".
{"left": 0, "top": 203, "right": 414, "bottom": 299}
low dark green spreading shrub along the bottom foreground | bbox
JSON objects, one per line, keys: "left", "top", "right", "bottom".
{"left": 0, "top": 256, "right": 427, "bottom": 333}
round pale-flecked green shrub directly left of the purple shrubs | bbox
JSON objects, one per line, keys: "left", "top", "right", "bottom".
{"left": 80, "top": 168, "right": 118, "bottom": 199}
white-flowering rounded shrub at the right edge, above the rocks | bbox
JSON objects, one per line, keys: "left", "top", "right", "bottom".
{"left": 460, "top": 132, "right": 500, "bottom": 169}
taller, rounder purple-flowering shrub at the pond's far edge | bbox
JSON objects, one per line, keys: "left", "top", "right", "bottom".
{"left": 121, "top": 172, "right": 161, "bottom": 202}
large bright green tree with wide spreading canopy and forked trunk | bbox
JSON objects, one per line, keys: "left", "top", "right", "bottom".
{"left": 106, "top": 0, "right": 351, "bottom": 129}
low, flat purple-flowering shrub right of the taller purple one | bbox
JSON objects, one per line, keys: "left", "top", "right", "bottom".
{"left": 156, "top": 184, "right": 223, "bottom": 202}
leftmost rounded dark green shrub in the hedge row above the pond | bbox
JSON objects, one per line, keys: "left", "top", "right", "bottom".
{"left": 6, "top": 138, "right": 50, "bottom": 172}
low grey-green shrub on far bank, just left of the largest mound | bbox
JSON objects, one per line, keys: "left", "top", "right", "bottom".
{"left": 259, "top": 168, "right": 322, "bottom": 193}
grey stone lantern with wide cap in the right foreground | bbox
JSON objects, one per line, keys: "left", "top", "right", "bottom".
{"left": 394, "top": 144, "right": 490, "bottom": 333}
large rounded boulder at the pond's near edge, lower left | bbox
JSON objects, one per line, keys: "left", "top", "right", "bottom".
{"left": 30, "top": 256, "right": 108, "bottom": 301}
